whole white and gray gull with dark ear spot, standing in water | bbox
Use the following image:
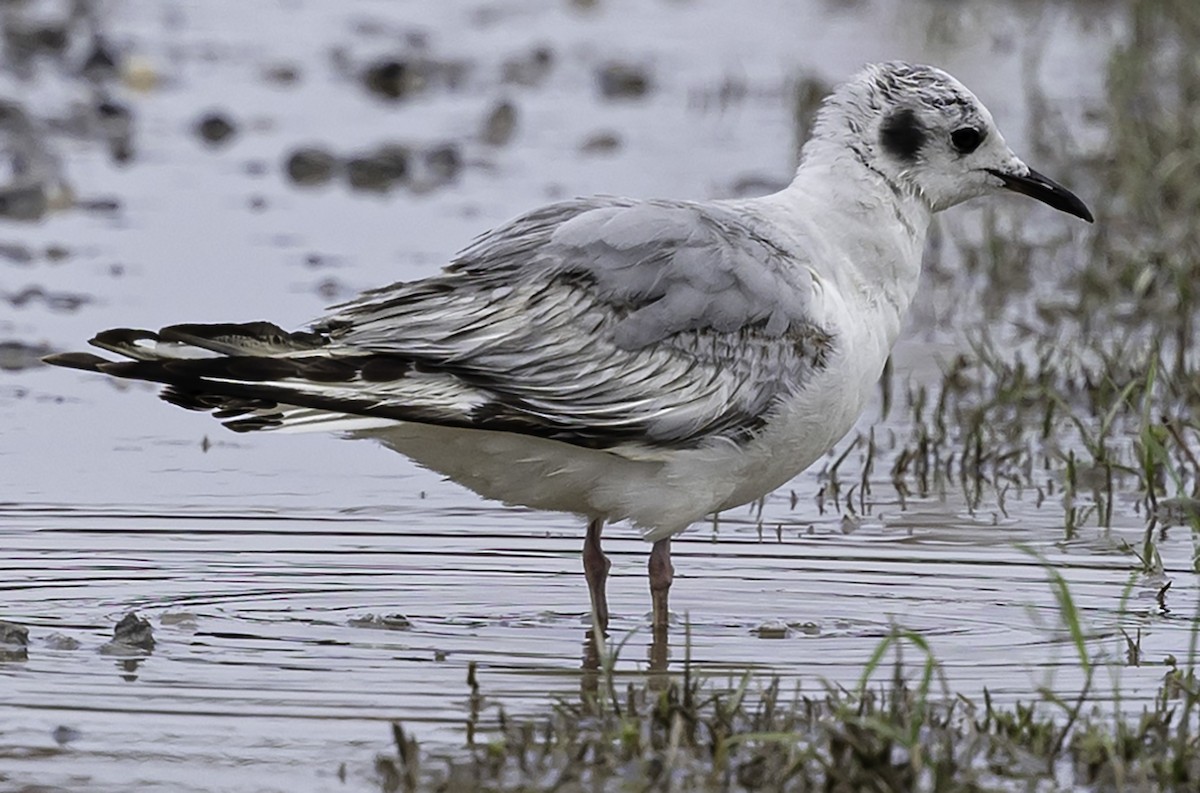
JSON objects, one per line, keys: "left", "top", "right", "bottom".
{"left": 47, "top": 62, "right": 1092, "bottom": 635}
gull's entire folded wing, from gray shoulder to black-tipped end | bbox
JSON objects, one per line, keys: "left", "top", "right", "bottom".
{"left": 46, "top": 198, "right": 836, "bottom": 457}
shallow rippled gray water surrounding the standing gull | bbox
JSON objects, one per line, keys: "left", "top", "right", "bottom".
{"left": 0, "top": 0, "right": 1200, "bottom": 791}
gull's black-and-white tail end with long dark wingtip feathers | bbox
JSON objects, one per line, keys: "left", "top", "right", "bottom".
{"left": 44, "top": 322, "right": 470, "bottom": 432}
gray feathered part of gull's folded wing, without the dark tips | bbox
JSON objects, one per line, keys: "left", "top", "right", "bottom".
{"left": 313, "top": 198, "right": 834, "bottom": 449}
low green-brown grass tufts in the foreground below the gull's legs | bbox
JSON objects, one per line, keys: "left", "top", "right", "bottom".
{"left": 374, "top": 595, "right": 1200, "bottom": 793}
